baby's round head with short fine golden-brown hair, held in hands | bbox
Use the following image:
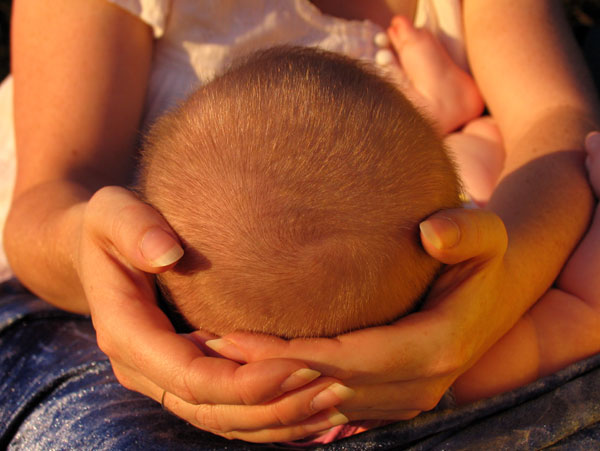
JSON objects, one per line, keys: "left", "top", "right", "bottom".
{"left": 139, "top": 47, "right": 460, "bottom": 337}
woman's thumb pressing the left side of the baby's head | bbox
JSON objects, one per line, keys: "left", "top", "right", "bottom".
{"left": 85, "top": 186, "right": 183, "bottom": 273}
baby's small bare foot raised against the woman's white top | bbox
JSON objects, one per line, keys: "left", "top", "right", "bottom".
{"left": 388, "top": 16, "right": 484, "bottom": 133}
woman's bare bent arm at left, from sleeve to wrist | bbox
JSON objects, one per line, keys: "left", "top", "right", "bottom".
{"left": 5, "top": 0, "right": 152, "bottom": 313}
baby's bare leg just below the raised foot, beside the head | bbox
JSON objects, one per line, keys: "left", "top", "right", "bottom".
{"left": 445, "top": 116, "right": 504, "bottom": 206}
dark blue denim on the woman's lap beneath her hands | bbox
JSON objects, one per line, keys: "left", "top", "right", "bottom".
{"left": 0, "top": 283, "right": 600, "bottom": 451}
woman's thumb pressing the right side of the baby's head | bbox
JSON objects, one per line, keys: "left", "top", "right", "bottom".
{"left": 419, "top": 208, "right": 508, "bottom": 264}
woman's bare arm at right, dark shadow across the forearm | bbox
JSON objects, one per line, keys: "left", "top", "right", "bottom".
{"left": 463, "top": 0, "right": 599, "bottom": 314}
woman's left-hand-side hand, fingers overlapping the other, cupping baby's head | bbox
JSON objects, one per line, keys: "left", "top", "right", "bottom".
{"left": 77, "top": 187, "right": 352, "bottom": 441}
